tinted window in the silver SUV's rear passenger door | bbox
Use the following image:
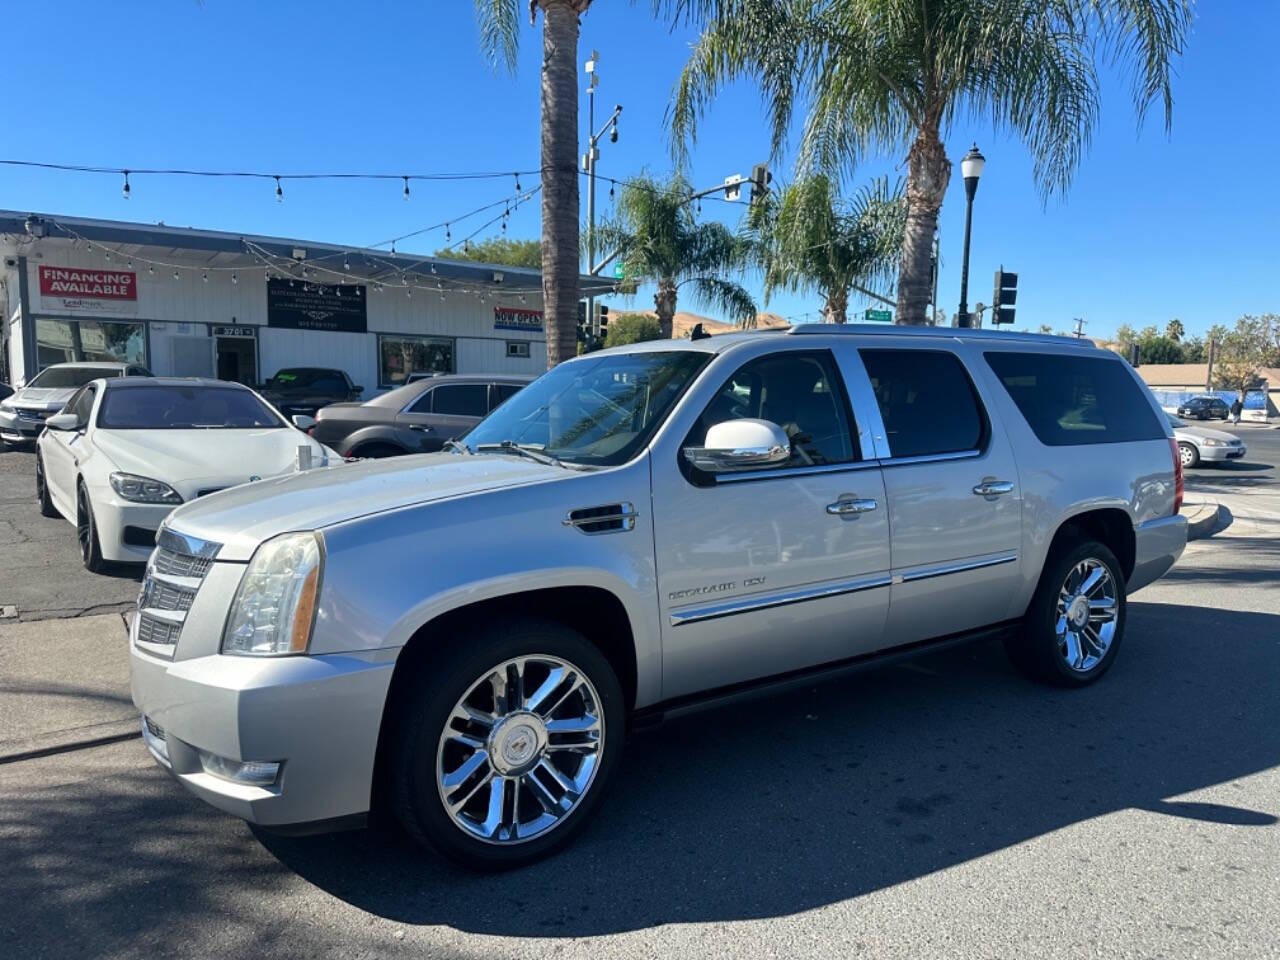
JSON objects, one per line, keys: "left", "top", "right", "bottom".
{"left": 859, "top": 349, "right": 987, "bottom": 457}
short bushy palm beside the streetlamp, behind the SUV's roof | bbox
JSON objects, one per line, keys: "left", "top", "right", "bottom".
{"left": 748, "top": 174, "right": 906, "bottom": 324}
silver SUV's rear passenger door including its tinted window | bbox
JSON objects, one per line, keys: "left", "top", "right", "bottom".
{"left": 859, "top": 346, "right": 1023, "bottom": 646}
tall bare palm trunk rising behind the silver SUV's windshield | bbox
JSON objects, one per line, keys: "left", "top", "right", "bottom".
{"left": 476, "top": 0, "right": 591, "bottom": 367}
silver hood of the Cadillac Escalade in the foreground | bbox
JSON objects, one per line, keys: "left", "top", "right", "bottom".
{"left": 158, "top": 453, "right": 565, "bottom": 561}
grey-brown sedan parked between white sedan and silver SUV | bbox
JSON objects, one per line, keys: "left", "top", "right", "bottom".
{"left": 310, "top": 374, "right": 534, "bottom": 457}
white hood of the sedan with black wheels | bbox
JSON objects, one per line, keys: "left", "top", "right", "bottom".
{"left": 93, "top": 429, "right": 340, "bottom": 500}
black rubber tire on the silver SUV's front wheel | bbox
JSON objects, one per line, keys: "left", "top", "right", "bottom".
{"left": 389, "top": 618, "right": 626, "bottom": 870}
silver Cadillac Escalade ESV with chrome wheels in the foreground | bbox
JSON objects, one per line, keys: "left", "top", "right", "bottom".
{"left": 131, "top": 325, "right": 1187, "bottom": 868}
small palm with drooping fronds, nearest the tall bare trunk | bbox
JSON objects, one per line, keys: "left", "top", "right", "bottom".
{"left": 595, "top": 174, "right": 755, "bottom": 339}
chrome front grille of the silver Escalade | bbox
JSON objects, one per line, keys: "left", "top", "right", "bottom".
{"left": 137, "top": 527, "right": 221, "bottom": 657}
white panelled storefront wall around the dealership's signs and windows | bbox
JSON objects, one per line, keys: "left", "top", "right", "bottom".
{"left": 13, "top": 241, "right": 547, "bottom": 398}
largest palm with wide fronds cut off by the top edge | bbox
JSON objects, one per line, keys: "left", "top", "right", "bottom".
{"left": 654, "top": 0, "right": 1193, "bottom": 324}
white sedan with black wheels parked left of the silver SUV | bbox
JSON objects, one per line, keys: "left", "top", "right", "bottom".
{"left": 36, "top": 378, "right": 342, "bottom": 572}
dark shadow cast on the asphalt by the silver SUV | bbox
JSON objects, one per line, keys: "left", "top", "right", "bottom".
{"left": 257, "top": 603, "right": 1280, "bottom": 936}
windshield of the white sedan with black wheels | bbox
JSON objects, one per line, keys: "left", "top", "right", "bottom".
{"left": 97, "top": 387, "right": 285, "bottom": 430}
